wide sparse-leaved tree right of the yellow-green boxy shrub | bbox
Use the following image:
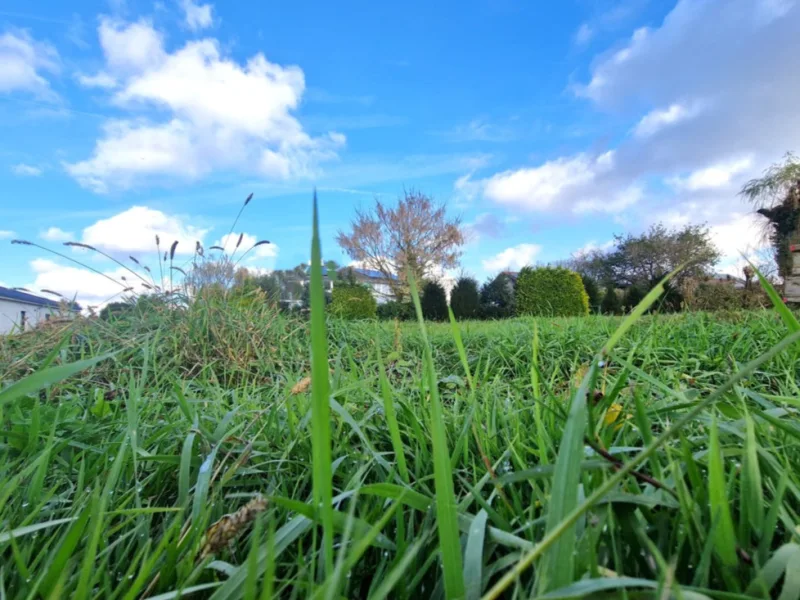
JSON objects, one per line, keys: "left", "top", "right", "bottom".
{"left": 592, "top": 223, "right": 720, "bottom": 290}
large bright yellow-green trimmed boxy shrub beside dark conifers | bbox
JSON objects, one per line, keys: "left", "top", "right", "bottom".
{"left": 516, "top": 267, "right": 589, "bottom": 317}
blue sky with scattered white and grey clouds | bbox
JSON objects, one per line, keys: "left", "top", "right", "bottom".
{"left": 0, "top": 0, "right": 800, "bottom": 305}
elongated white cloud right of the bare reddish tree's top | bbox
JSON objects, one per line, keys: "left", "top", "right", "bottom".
{"left": 482, "top": 152, "right": 614, "bottom": 210}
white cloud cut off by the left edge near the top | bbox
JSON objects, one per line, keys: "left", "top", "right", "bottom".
{"left": 0, "top": 31, "right": 59, "bottom": 101}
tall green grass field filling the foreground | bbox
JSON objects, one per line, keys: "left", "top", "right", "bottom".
{"left": 0, "top": 288, "right": 800, "bottom": 599}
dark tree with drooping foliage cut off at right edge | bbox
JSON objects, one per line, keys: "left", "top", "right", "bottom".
{"left": 740, "top": 154, "right": 800, "bottom": 278}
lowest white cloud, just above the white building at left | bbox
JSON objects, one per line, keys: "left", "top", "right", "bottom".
{"left": 30, "top": 258, "right": 130, "bottom": 308}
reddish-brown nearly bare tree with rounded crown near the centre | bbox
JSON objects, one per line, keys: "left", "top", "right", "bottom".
{"left": 336, "top": 190, "right": 464, "bottom": 301}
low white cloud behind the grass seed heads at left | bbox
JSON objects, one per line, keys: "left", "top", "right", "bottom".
{"left": 81, "top": 206, "right": 208, "bottom": 255}
